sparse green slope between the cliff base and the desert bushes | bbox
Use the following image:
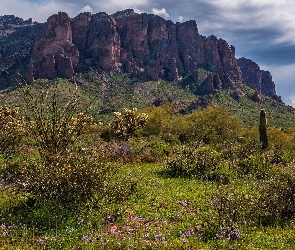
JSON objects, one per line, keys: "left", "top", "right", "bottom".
{"left": 0, "top": 71, "right": 295, "bottom": 128}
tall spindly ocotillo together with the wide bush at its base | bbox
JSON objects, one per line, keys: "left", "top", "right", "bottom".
{"left": 1, "top": 79, "right": 138, "bottom": 208}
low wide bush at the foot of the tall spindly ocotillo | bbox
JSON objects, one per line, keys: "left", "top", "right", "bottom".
{"left": 1, "top": 148, "right": 136, "bottom": 209}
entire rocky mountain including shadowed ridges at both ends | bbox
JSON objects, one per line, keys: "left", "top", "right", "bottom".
{"left": 0, "top": 9, "right": 280, "bottom": 100}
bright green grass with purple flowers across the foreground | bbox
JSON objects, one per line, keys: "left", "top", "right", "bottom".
{"left": 0, "top": 163, "right": 295, "bottom": 249}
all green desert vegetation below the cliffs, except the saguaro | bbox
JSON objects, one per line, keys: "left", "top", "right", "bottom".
{"left": 0, "top": 77, "right": 295, "bottom": 249}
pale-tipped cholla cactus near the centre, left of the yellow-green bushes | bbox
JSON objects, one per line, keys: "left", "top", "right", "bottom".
{"left": 110, "top": 108, "right": 148, "bottom": 139}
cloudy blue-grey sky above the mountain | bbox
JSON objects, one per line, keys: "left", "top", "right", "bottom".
{"left": 0, "top": 0, "right": 295, "bottom": 107}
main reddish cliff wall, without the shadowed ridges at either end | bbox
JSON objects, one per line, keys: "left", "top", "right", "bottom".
{"left": 28, "top": 9, "right": 242, "bottom": 89}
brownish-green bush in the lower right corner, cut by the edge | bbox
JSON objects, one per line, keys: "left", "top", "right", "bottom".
{"left": 205, "top": 166, "right": 295, "bottom": 232}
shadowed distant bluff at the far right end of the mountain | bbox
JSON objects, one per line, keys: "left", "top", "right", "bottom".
{"left": 237, "top": 57, "right": 276, "bottom": 97}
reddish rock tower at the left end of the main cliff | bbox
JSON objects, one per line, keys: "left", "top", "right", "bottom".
{"left": 29, "top": 12, "right": 79, "bottom": 80}
